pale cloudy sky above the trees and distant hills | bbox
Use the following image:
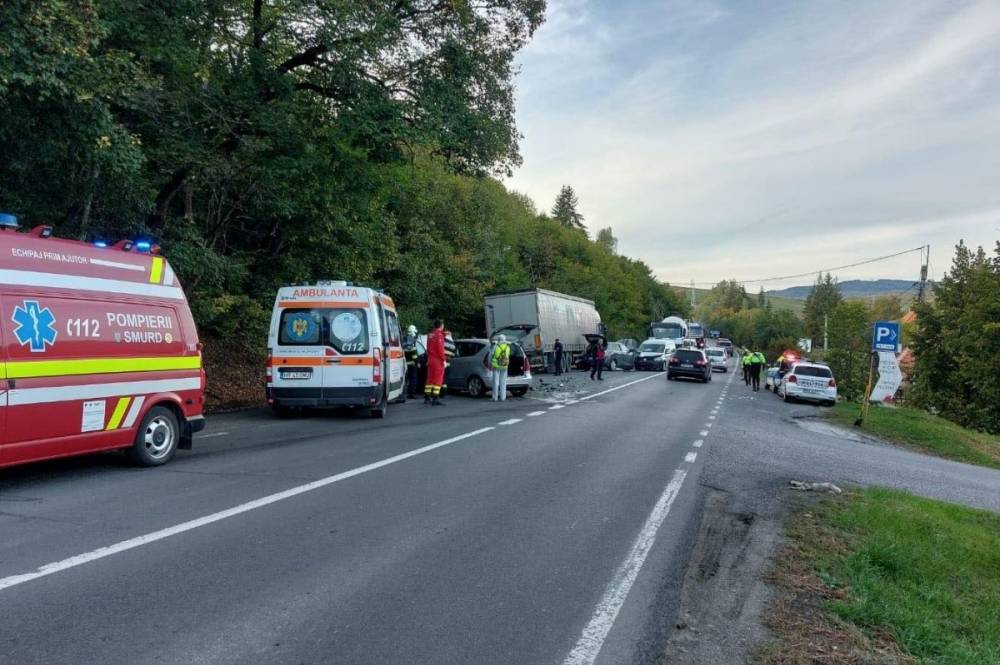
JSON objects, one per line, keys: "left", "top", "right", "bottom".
{"left": 508, "top": 0, "right": 1000, "bottom": 290}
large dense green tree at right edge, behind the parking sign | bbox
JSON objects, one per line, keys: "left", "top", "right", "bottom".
{"left": 913, "top": 243, "right": 1000, "bottom": 434}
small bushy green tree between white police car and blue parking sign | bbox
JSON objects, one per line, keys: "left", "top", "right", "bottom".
{"left": 826, "top": 300, "right": 871, "bottom": 401}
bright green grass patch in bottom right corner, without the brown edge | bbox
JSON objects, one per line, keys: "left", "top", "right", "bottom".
{"left": 789, "top": 489, "right": 1000, "bottom": 665}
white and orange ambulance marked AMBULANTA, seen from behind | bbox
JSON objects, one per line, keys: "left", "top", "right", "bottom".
{"left": 266, "top": 281, "right": 406, "bottom": 418}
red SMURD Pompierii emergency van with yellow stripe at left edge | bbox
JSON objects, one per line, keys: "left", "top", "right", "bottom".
{"left": 0, "top": 214, "right": 205, "bottom": 467}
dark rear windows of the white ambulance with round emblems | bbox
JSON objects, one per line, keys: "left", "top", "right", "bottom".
{"left": 278, "top": 308, "right": 368, "bottom": 354}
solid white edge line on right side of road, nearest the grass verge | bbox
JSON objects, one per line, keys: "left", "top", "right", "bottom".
{"left": 563, "top": 469, "right": 687, "bottom": 665}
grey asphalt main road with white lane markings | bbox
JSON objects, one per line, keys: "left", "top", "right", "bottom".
{"left": 0, "top": 372, "right": 728, "bottom": 665}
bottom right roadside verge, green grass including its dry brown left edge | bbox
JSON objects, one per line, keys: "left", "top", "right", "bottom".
{"left": 753, "top": 489, "right": 1000, "bottom": 665}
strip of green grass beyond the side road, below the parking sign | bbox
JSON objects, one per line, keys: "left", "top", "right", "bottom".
{"left": 828, "top": 402, "right": 1000, "bottom": 469}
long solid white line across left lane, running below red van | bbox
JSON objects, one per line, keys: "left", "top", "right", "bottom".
{"left": 0, "top": 427, "right": 495, "bottom": 591}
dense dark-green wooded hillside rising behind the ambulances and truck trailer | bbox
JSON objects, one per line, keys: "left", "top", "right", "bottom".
{"left": 0, "top": 0, "right": 682, "bottom": 344}
